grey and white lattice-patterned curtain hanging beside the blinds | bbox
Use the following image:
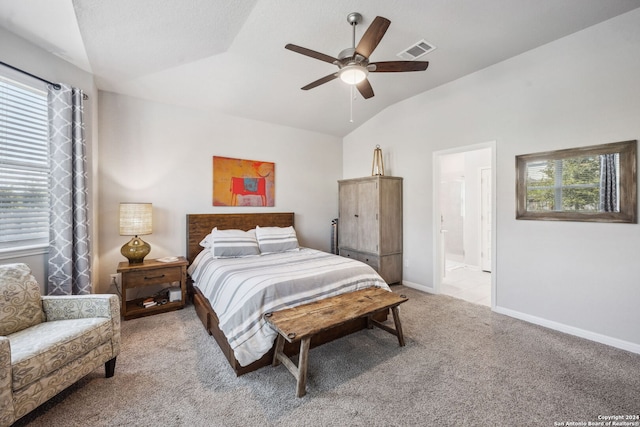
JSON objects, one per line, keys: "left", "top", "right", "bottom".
{"left": 47, "top": 84, "right": 91, "bottom": 295}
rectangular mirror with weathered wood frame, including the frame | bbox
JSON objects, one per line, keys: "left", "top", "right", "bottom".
{"left": 516, "top": 140, "right": 638, "bottom": 224}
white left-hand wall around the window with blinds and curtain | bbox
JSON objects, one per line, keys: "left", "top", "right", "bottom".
{"left": 0, "top": 28, "right": 98, "bottom": 292}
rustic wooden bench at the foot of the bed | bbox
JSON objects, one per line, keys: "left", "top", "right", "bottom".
{"left": 265, "top": 288, "right": 407, "bottom": 397}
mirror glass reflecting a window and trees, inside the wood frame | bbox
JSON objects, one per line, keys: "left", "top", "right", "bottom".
{"left": 526, "top": 153, "right": 620, "bottom": 212}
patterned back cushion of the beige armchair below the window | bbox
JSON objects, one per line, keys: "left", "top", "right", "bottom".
{"left": 0, "top": 263, "right": 44, "bottom": 336}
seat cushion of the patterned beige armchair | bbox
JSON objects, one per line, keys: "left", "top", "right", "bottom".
{"left": 8, "top": 317, "right": 113, "bottom": 390}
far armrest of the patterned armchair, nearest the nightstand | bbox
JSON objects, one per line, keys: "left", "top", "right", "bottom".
{"left": 42, "top": 294, "right": 120, "bottom": 322}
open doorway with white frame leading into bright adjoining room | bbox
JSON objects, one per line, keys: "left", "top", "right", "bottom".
{"left": 433, "top": 142, "right": 495, "bottom": 307}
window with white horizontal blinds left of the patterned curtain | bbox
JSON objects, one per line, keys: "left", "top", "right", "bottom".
{"left": 0, "top": 71, "right": 49, "bottom": 251}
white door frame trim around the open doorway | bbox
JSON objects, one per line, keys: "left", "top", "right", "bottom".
{"left": 432, "top": 141, "right": 498, "bottom": 310}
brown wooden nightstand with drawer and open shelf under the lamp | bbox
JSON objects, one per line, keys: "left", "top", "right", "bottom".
{"left": 118, "top": 257, "right": 189, "bottom": 320}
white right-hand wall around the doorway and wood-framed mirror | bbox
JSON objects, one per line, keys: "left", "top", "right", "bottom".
{"left": 343, "top": 10, "right": 640, "bottom": 352}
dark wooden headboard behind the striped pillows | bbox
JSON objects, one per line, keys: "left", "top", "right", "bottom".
{"left": 187, "top": 212, "right": 294, "bottom": 263}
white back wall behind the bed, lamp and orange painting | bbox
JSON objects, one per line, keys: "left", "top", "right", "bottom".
{"left": 98, "top": 92, "right": 342, "bottom": 292}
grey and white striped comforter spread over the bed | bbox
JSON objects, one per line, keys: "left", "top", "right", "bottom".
{"left": 188, "top": 248, "right": 390, "bottom": 366}
